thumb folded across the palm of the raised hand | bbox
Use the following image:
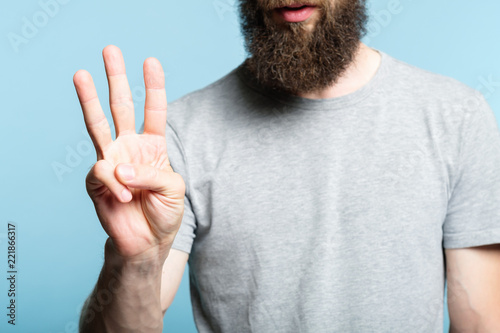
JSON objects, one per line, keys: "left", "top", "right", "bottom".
{"left": 115, "top": 163, "right": 185, "bottom": 198}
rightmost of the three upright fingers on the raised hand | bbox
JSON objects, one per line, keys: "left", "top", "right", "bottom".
{"left": 144, "top": 58, "right": 167, "bottom": 136}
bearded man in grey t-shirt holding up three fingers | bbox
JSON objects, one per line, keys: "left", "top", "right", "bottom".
{"left": 74, "top": 0, "right": 500, "bottom": 333}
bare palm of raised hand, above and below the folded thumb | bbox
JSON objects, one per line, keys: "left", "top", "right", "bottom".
{"left": 95, "top": 134, "right": 182, "bottom": 252}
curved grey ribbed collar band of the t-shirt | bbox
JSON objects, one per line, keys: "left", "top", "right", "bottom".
{"left": 236, "top": 49, "right": 390, "bottom": 110}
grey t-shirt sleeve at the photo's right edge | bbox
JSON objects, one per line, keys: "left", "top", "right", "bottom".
{"left": 443, "top": 92, "right": 500, "bottom": 248}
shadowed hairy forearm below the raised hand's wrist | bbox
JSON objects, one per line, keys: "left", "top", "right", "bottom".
{"left": 80, "top": 242, "right": 164, "bottom": 333}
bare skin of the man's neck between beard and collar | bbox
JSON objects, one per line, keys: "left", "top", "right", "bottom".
{"left": 297, "top": 42, "right": 381, "bottom": 99}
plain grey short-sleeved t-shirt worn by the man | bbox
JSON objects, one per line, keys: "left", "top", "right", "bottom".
{"left": 167, "top": 52, "right": 500, "bottom": 333}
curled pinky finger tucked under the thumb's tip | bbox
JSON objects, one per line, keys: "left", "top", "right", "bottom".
{"left": 87, "top": 160, "right": 132, "bottom": 203}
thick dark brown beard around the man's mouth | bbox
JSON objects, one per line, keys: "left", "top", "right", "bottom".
{"left": 240, "top": 0, "right": 367, "bottom": 95}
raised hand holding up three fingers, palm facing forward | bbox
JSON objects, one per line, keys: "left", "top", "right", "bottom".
{"left": 73, "top": 46, "right": 185, "bottom": 261}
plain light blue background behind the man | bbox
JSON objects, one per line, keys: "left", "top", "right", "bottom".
{"left": 0, "top": 0, "right": 500, "bottom": 333}
